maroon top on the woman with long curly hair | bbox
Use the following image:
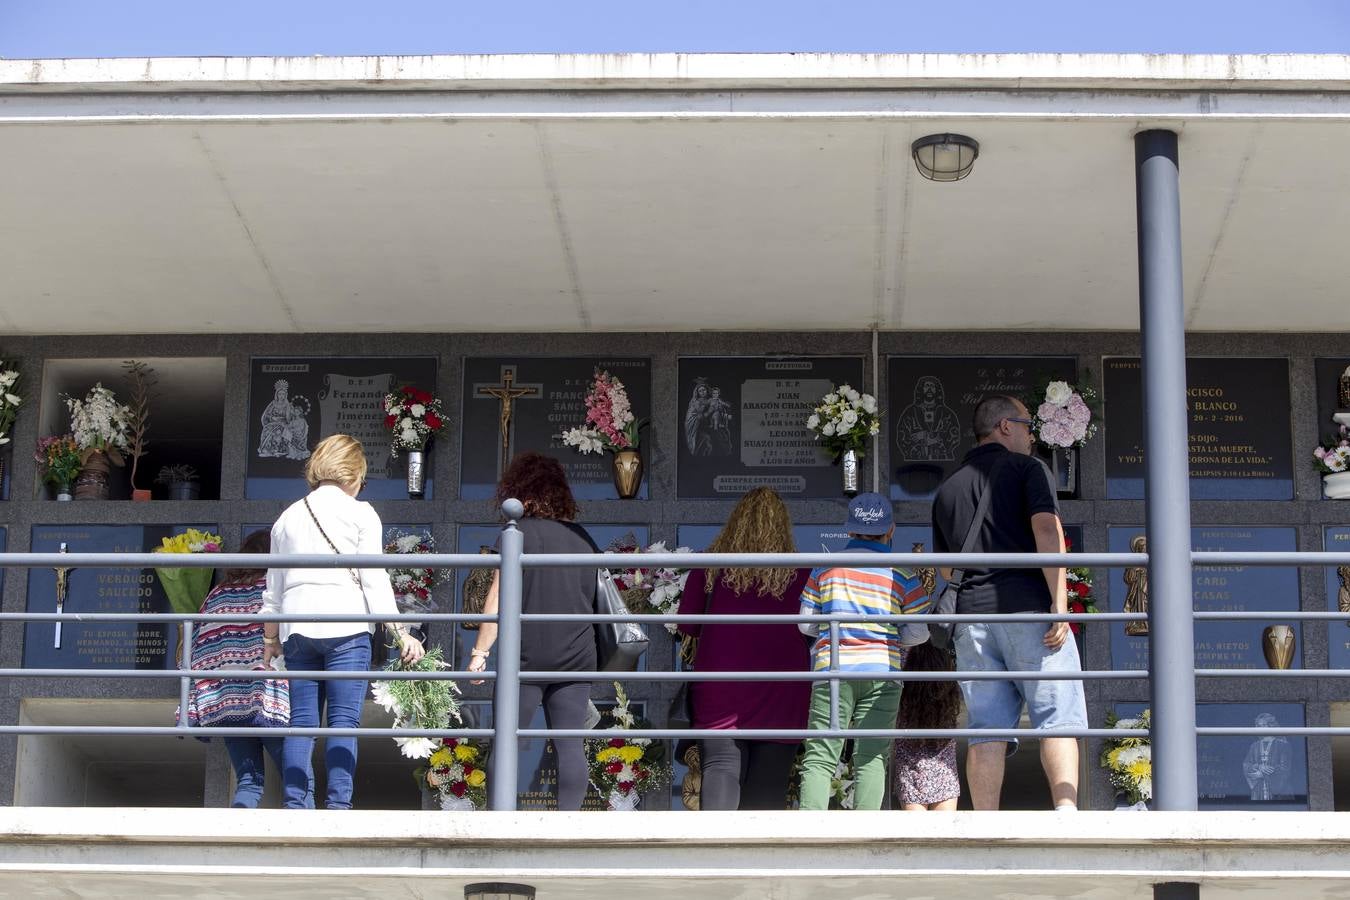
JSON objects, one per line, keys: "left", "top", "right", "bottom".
{"left": 679, "top": 569, "right": 811, "bottom": 743}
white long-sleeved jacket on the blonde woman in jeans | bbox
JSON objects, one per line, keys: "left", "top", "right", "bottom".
{"left": 259, "top": 484, "right": 398, "bottom": 644}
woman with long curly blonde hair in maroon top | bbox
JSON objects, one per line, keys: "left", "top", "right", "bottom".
{"left": 679, "top": 487, "right": 811, "bottom": 810}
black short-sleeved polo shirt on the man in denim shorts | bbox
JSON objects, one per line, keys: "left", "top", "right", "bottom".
{"left": 933, "top": 443, "right": 1060, "bottom": 613}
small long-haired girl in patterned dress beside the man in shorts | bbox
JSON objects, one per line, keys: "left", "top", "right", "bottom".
{"left": 895, "top": 642, "right": 961, "bottom": 811}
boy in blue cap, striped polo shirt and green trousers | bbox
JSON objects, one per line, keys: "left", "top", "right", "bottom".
{"left": 801, "top": 494, "right": 932, "bottom": 810}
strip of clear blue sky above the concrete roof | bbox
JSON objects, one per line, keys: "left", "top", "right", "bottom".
{"left": 0, "top": 0, "right": 1350, "bottom": 58}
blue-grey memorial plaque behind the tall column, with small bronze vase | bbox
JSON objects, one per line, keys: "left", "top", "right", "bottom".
{"left": 1099, "top": 526, "right": 1303, "bottom": 669}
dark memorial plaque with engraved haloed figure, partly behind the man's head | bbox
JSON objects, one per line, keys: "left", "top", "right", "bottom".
{"left": 883, "top": 356, "right": 1077, "bottom": 499}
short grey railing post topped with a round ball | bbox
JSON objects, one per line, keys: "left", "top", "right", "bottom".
{"left": 489, "top": 499, "right": 525, "bottom": 811}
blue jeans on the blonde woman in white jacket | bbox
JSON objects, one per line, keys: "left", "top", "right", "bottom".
{"left": 282, "top": 631, "right": 370, "bottom": 810}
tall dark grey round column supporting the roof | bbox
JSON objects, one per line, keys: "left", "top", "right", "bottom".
{"left": 1134, "top": 131, "right": 1196, "bottom": 810}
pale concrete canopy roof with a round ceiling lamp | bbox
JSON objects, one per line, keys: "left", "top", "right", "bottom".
{"left": 0, "top": 54, "right": 1350, "bottom": 333}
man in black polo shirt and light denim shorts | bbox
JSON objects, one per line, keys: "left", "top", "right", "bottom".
{"left": 933, "top": 395, "right": 1087, "bottom": 810}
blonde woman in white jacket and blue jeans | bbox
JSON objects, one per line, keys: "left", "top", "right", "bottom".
{"left": 261, "top": 434, "right": 423, "bottom": 810}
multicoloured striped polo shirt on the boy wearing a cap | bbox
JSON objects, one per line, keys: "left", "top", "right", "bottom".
{"left": 802, "top": 538, "right": 933, "bottom": 672}
